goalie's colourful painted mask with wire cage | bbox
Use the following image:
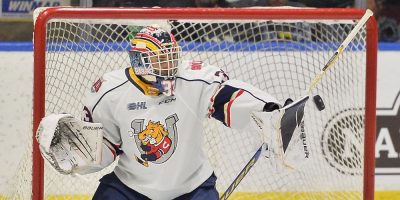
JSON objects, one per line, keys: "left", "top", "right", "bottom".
{"left": 129, "top": 25, "right": 181, "bottom": 94}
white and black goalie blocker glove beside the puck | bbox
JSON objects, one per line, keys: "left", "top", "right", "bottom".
{"left": 252, "top": 96, "right": 311, "bottom": 169}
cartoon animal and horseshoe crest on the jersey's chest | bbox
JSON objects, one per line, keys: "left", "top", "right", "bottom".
{"left": 131, "top": 113, "right": 179, "bottom": 167}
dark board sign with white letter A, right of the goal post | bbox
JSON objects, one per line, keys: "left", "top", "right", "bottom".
{"left": 375, "top": 93, "right": 400, "bottom": 175}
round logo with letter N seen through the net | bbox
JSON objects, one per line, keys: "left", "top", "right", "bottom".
{"left": 321, "top": 108, "right": 364, "bottom": 175}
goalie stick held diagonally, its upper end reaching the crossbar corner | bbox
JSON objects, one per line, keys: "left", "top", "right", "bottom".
{"left": 220, "top": 9, "right": 373, "bottom": 200}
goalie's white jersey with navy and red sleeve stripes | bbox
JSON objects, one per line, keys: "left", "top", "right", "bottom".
{"left": 83, "top": 61, "right": 277, "bottom": 199}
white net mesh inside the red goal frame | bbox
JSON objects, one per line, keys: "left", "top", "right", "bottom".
{"left": 3, "top": 7, "right": 376, "bottom": 199}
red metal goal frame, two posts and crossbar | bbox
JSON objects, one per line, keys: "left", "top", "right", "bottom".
{"left": 32, "top": 7, "right": 377, "bottom": 200}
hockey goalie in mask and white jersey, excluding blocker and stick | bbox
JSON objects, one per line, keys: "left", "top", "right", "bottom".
{"left": 37, "top": 25, "right": 304, "bottom": 200}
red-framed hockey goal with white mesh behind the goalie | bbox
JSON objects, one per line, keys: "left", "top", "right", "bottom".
{"left": 8, "top": 8, "right": 376, "bottom": 199}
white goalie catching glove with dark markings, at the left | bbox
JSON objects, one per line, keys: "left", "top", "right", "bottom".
{"left": 36, "top": 114, "right": 113, "bottom": 174}
